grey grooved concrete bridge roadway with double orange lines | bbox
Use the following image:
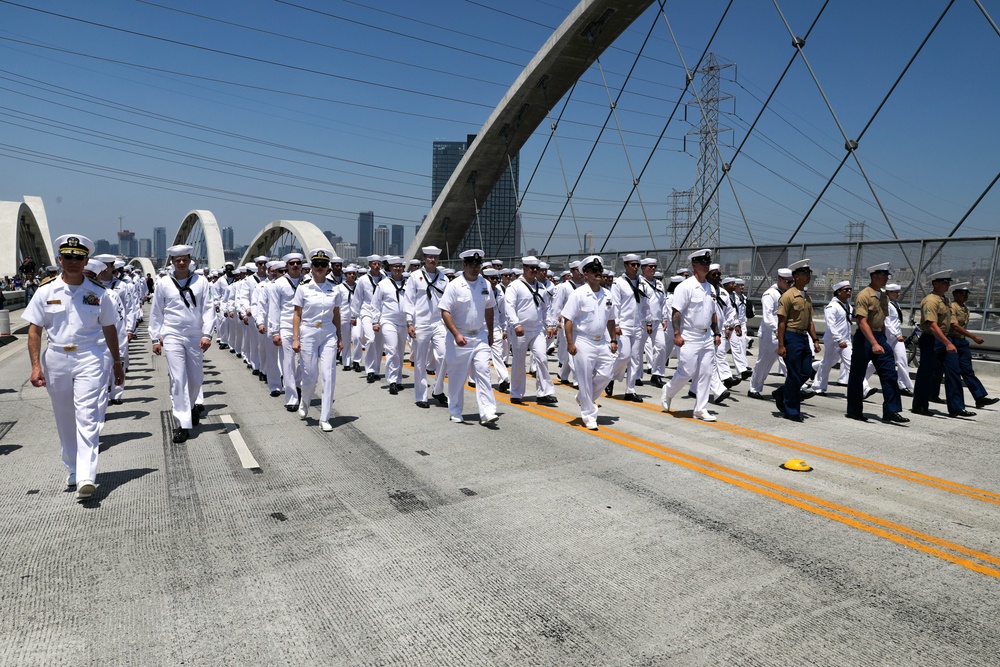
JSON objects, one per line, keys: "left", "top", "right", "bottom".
{"left": 0, "top": 310, "right": 1000, "bottom": 665}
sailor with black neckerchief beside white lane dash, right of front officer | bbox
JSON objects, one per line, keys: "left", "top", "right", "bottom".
{"left": 149, "top": 245, "right": 215, "bottom": 443}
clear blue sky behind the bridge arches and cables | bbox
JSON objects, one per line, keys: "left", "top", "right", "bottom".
{"left": 0, "top": 0, "right": 1000, "bottom": 252}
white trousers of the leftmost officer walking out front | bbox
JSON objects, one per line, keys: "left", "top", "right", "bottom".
{"left": 42, "top": 347, "right": 108, "bottom": 482}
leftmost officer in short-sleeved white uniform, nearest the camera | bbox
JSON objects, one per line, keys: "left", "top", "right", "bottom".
{"left": 21, "top": 234, "right": 125, "bottom": 500}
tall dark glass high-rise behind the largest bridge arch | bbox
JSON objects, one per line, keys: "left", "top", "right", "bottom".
{"left": 431, "top": 134, "right": 521, "bottom": 257}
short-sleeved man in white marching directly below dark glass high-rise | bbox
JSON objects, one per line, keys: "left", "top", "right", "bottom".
{"left": 438, "top": 249, "right": 499, "bottom": 426}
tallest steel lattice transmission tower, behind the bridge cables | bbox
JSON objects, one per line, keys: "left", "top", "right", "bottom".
{"left": 687, "top": 53, "right": 733, "bottom": 248}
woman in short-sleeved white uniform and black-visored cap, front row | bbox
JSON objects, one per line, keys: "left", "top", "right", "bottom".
{"left": 292, "top": 248, "right": 344, "bottom": 432}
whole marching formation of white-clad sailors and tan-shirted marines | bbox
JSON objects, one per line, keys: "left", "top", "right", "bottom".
{"left": 23, "top": 239, "right": 998, "bottom": 500}
